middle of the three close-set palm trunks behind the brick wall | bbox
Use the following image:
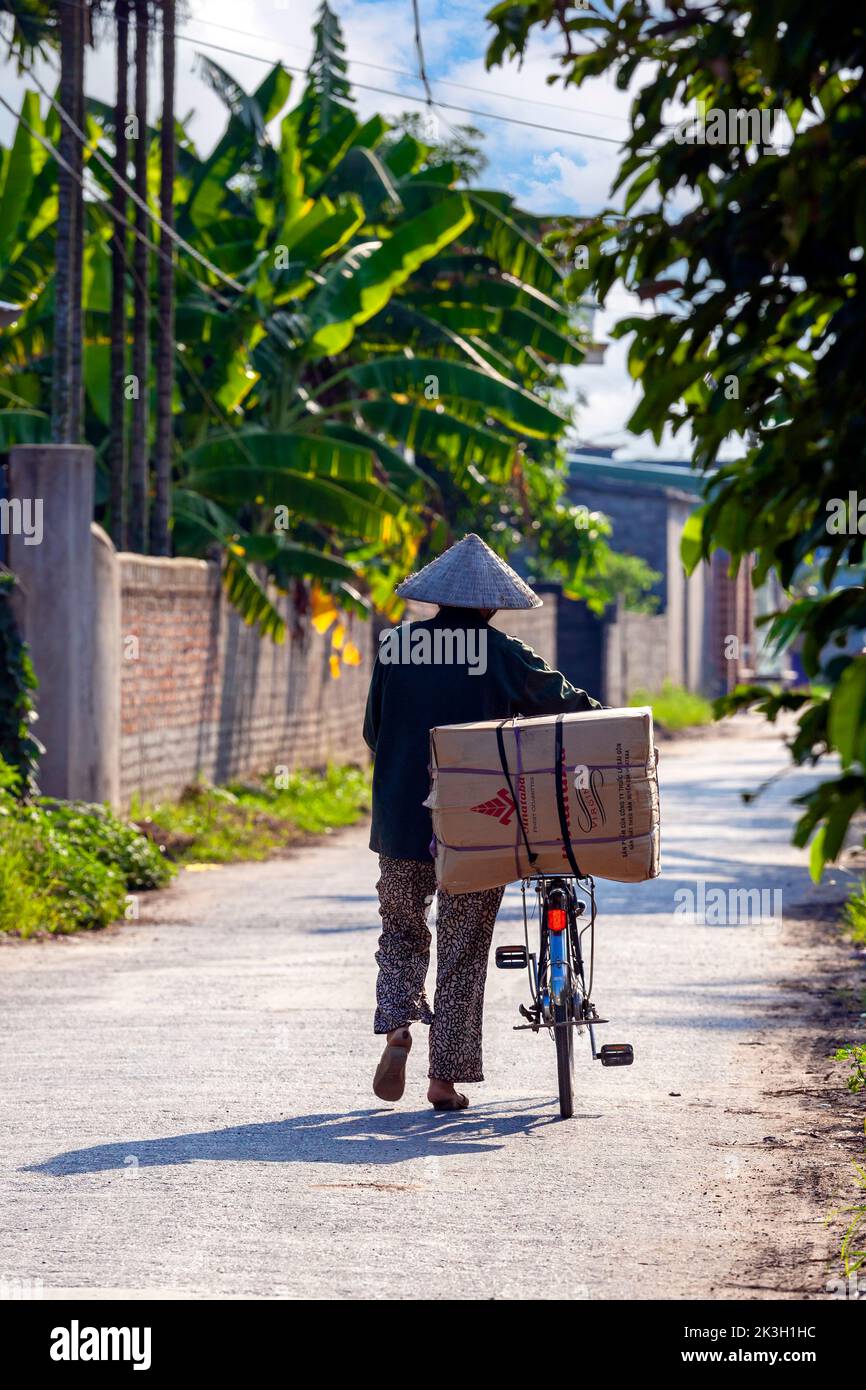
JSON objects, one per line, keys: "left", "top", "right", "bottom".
{"left": 129, "top": 0, "right": 150, "bottom": 553}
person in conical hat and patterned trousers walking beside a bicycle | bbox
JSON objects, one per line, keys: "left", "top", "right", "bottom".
{"left": 364, "top": 534, "right": 602, "bottom": 1111}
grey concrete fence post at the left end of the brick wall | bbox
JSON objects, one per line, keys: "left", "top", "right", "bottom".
{"left": 8, "top": 445, "right": 120, "bottom": 801}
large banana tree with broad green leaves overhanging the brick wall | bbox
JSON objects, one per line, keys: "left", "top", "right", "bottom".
{"left": 159, "top": 31, "right": 601, "bottom": 631}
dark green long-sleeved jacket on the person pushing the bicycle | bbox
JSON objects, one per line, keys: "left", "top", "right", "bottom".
{"left": 364, "top": 609, "right": 602, "bottom": 860}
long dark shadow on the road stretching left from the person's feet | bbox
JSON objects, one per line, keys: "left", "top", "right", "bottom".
{"left": 22, "top": 1099, "right": 601, "bottom": 1177}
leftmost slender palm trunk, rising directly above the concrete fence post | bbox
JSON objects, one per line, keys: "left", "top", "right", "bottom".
{"left": 51, "top": 6, "right": 78, "bottom": 443}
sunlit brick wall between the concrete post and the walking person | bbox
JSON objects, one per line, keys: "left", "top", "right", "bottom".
{"left": 118, "top": 555, "right": 371, "bottom": 803}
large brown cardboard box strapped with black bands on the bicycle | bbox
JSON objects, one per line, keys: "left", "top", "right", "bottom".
{"left": 425, "top": 709, "right": 659, "bottom": 892}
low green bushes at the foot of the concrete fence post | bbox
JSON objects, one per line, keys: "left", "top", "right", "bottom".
{"left": 0, "top": 758, "right": 172, "bottom": 937}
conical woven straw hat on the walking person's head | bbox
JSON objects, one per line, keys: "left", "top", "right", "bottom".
{"left": 396, "top": 532, "right": 542, "bottom": 609}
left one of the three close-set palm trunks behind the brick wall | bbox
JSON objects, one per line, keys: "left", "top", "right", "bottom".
{"left": 108, "top": 0, "right": 129, "bottom": 550}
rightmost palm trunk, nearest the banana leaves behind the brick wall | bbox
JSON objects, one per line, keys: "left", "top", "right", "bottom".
{"left": 152, "top": 0, "right": 175, "bottom": 555}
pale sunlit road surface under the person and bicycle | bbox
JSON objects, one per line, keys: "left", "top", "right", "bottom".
{"left": 0, "top": 726, "right": 851, "bottom": 1300}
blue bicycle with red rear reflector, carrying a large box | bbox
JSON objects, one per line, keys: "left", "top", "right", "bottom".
{"left": 496, "top": 874, "right": 634, "bottom": 1120}
